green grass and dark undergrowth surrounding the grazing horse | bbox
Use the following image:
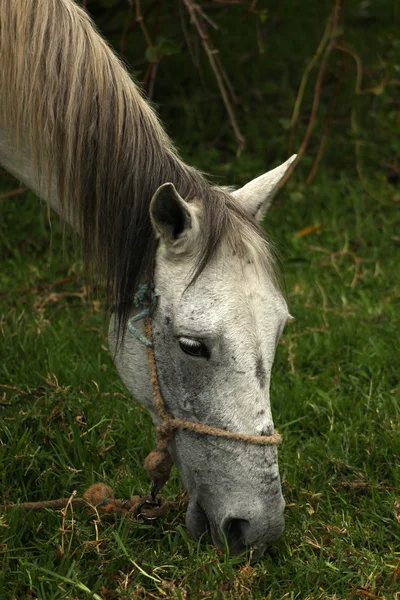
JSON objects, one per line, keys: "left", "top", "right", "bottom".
{"left": 0, "top": 0, "right": 400, "bottom": 600}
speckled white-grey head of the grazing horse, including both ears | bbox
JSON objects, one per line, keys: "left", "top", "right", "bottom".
{"left": 110, "top": 158, "right": 293, "bottom": 556}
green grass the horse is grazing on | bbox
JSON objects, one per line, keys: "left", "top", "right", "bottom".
{"left": 0, "top": 3, "right": 400, "bottom": 600}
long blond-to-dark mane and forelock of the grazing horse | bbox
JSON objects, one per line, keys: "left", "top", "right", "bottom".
{"left": 0, "top": 0, "right": 278, "bottom": 340}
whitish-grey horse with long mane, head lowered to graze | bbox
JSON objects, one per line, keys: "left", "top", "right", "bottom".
{"left": 0, "top": 0, "right": 294, "bottom": 556}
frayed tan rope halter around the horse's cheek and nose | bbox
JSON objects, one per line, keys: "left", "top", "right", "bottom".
{"left": 128, "top": 285, "right": 282, "bottom": 497}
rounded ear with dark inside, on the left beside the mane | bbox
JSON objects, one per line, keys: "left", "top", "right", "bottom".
{"left": 150, "top": 183, "right": 193, "bottom": 242}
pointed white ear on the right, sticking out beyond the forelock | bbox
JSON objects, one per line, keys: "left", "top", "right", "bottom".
{"left": 233, "top": 154, "right": 297, "bottom": 221}
